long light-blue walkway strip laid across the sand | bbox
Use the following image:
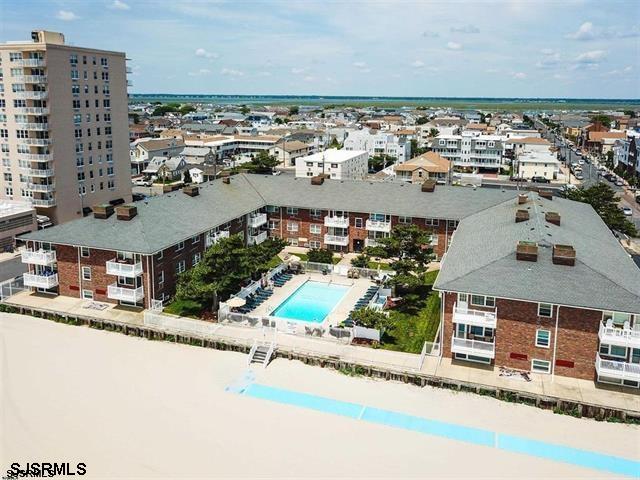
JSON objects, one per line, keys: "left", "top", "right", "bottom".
{"left": 239, "top": 380, "right": 640, "bottom": 478}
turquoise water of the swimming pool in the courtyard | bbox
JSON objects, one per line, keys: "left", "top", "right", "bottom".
{"left": 271, "top": 280, "right": 349, "bottom": 323}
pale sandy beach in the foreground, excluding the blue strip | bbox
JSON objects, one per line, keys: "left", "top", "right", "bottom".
{"left": 0, "top": 314, "right": 640, "bottom": 479}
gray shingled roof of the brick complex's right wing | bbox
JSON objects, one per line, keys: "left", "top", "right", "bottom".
{"left": 434, "top": 193, "right": 640, "bottom": 313}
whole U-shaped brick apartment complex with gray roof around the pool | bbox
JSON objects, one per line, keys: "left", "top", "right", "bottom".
{"left": 16, "top": 174, "right": 640, "bottom": 386}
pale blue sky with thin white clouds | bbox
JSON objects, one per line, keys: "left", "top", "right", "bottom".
{"left": 0, "top": 0, "right": 640, "bottom": 99}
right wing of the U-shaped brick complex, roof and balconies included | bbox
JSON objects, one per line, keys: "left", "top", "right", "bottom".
{"left": 434, "top": 192, "right": 640, "bottom": 387}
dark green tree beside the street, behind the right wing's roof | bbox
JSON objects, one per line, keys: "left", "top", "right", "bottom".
{"left": 566, "top": 183, "right": 638, "bottom": 237}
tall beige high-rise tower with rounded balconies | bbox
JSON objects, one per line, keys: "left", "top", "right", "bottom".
{"left": 0, "top": 31, "right": 131, "bottom": 223}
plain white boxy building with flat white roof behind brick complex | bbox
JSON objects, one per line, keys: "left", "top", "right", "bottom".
{"left": 296, "top": 148, "right": 369, "bottom": 180}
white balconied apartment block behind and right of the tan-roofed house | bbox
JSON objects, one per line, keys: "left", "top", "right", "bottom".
{"left": 432, "top": 132, "right": 504, "bottom": 173}
